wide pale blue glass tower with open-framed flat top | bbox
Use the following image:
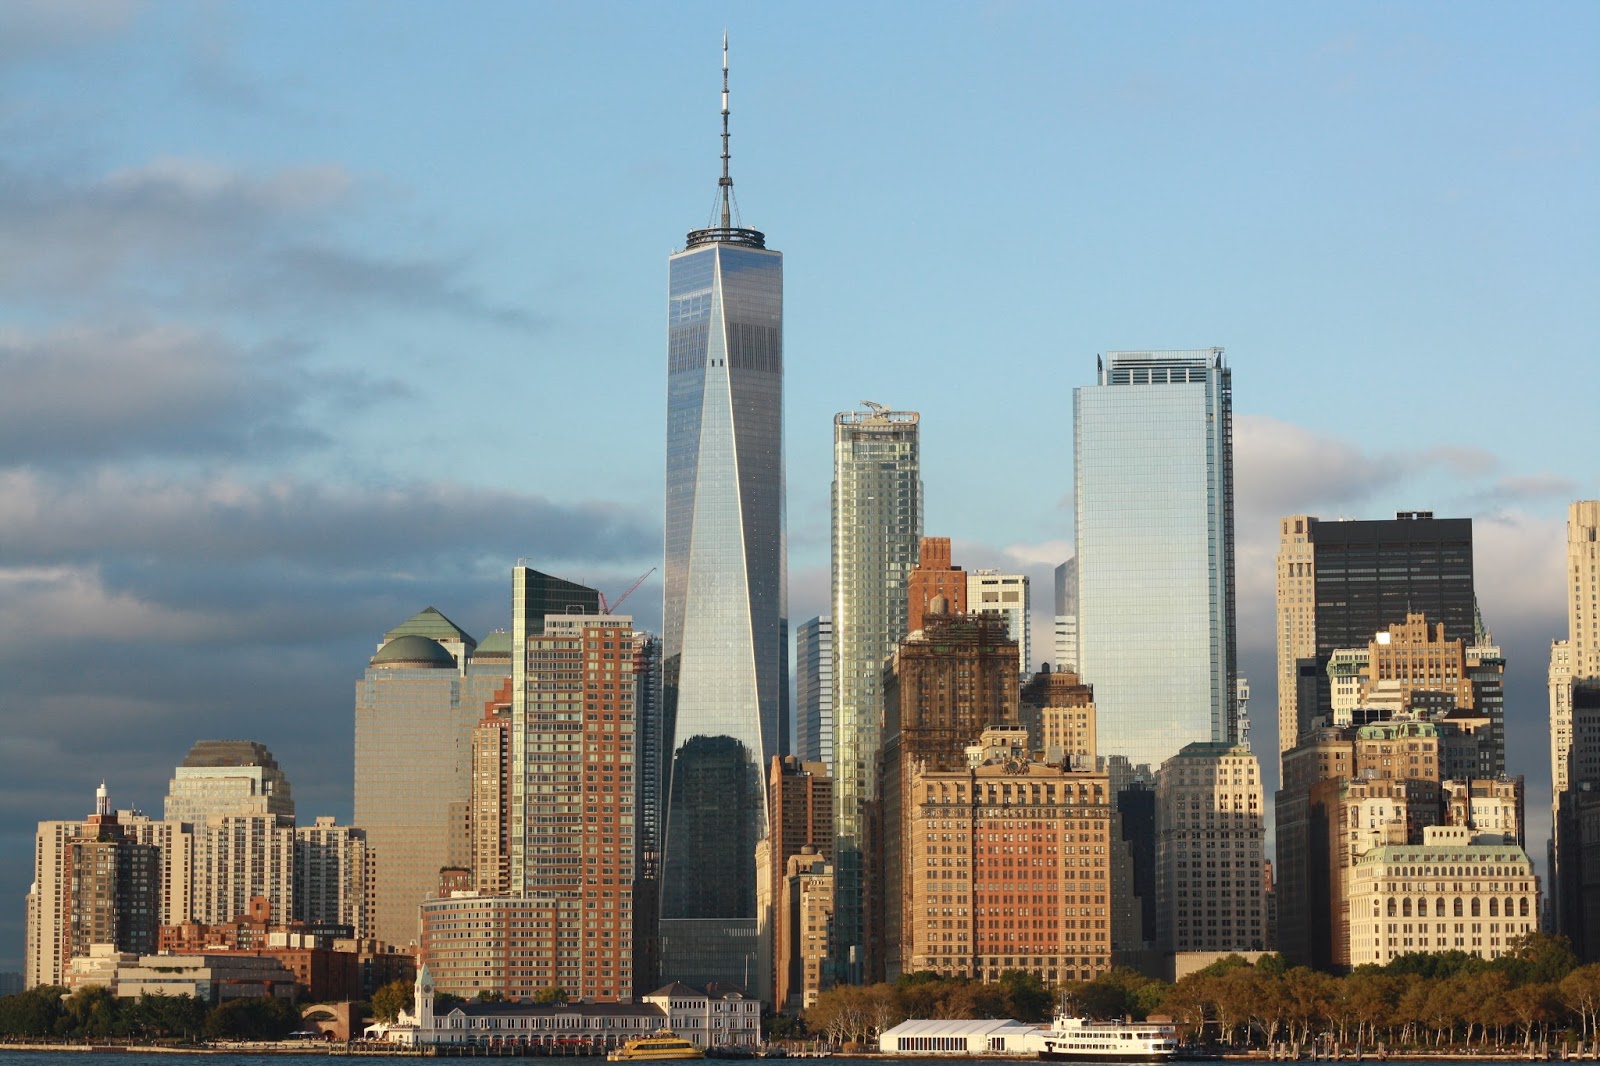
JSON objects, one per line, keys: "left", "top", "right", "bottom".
{"left": 1072, "top": 347, "right": 1238, "bottom": 767}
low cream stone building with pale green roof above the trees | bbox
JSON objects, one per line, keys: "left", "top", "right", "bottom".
{"left": 1350, "top": 826, "right": 1539, "bottom": 965}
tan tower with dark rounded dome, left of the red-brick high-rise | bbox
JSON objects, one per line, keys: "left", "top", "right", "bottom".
{"left": 360, "top": 607, "right": 509, "bottom": 946}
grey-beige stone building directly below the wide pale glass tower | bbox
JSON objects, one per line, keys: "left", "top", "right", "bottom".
{"left": 1155, "top": 743, "right": 1269, "bottom": 952}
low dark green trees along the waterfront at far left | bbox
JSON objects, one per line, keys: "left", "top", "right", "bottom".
{"left": 0, "top": 984, "right": 310, "bottom": 1044}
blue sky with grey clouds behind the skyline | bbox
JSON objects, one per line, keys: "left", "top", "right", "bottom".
{"left": 0, "top": 0, "right": 1600, "bottom": 970}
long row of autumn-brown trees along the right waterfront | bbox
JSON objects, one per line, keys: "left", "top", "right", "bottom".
{"left": 802, "top": 933, "right": 1600, "bottom": 1048}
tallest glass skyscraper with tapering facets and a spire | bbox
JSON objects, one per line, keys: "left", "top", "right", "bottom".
{"left": 661, "top": 40, "right": 789, "bottom": 984}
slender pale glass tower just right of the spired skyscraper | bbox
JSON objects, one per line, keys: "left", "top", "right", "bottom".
{"left": 830, "top": 403, "right": 922, "bottom": 965}
